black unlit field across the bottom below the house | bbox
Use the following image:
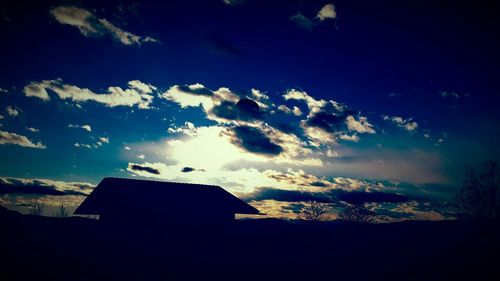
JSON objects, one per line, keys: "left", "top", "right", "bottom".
{"left": 0, "top": 206, "right": 500, "bottom": 280}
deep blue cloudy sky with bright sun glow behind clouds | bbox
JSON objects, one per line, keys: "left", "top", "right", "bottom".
{"left": 0, "top": 0, "right": 500, "bottom": 221}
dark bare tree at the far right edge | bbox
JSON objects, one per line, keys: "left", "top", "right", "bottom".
{"left": 455, "top": 162, "right": 500, "bottom": 219}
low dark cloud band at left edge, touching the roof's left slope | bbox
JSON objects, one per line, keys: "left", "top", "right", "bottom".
{"left": 0, "top": 177, "right": 94, "bottom": 196}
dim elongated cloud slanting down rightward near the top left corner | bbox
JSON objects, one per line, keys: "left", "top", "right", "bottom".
{"left": 50, "top": 6, "right": 158, "bottom": 45}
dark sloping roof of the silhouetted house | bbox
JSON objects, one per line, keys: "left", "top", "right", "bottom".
{"left": 75, "top": 178, "right": 259, "bottom": 215}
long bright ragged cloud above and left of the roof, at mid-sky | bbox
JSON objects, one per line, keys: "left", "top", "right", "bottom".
{"left": 24, "top": 79, "right": 156, "bottom": 109}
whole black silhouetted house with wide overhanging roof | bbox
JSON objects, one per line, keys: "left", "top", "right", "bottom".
{"left": 75, "top": 178, "right": 259, "bottom": 224}
